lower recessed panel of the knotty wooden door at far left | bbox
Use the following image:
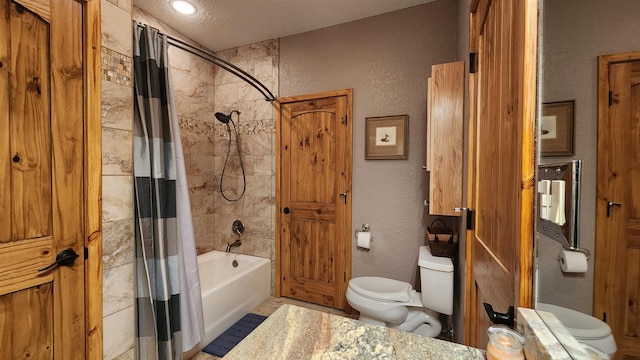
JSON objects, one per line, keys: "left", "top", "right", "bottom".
{"left": 0, "top": 283, "right": 53, "bottom": 360}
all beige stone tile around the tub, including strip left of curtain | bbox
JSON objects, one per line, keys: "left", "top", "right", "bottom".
{"left": 101, "top": 4, "right": 278, "bottom": 360}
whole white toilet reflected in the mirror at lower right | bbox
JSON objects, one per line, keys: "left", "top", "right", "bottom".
{"left": 536, "top": 303, "right": 618, "bottom": 358}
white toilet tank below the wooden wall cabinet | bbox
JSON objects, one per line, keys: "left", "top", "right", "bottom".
{"left": 418, "top": 246, "right": 453, "bottom": 315}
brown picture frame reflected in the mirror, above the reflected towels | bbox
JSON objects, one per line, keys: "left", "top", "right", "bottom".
{"left": 540, "top": 100, "right": 575, "bottom": 156}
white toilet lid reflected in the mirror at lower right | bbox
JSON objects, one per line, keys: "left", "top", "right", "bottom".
{"left": 536, "top": 303, "right": 611, "bottom": 339}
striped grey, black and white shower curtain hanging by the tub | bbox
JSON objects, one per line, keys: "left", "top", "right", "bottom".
{"left": 134, "top": 25, "right": 204, "bottom": 359}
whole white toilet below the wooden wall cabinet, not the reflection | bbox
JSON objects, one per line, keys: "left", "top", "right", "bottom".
{"left": 347, "top": 246, "right": 453, "bottom": 337}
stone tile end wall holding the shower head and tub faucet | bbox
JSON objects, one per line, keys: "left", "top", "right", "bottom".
{"left": 213, "top": 40, "right": 279, "bottom": 270}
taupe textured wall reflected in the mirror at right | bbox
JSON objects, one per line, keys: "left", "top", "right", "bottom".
{"left": 538, "top": 0, "right": 640, "bottom": 314}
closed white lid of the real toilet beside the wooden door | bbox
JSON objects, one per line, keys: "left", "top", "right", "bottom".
{"left": 349, "top": 276, "right": 411, "bottom": 302}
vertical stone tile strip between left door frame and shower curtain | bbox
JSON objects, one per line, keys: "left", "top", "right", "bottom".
{"left": 101, "top": 0, "right": 135, "bottom": 360}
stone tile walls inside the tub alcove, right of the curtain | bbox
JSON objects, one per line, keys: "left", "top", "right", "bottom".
{"left": 133, "top": 7, "right": 278, "bottom": 283}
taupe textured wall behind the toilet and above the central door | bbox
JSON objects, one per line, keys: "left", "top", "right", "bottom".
{"left": 280, "top": 1, "right": 456, "bottom": 290}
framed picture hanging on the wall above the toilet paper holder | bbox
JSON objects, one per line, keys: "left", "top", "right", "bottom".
{"left": 364, "top": 115, "right": 409, "bottom": 160}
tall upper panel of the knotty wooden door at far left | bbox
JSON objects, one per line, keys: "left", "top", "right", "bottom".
{"left": 5, "top": 0, "right": 51, "bottom": 242}
